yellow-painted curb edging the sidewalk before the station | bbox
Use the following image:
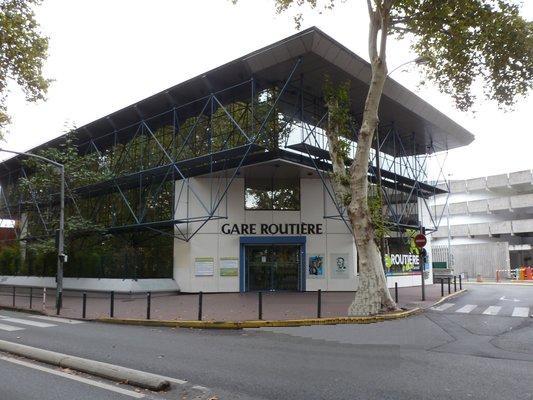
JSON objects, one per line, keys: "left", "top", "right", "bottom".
{"left": 93, "top": 307, "right": 422, "bottom": 329}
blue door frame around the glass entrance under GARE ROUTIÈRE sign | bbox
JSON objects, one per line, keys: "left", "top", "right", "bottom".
{"left": 239, "top": 236, "right": 306, "bottom": 292}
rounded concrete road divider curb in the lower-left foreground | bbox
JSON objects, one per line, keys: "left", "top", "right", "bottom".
{"left": 0, "top": 340, "right": 170, "bottom": 391}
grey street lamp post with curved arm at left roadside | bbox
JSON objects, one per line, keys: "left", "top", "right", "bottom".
{"left": 0, "top": 148, "right": 66, "bottom": 315}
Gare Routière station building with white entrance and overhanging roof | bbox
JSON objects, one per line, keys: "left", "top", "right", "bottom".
{"left": 0, "top": 28, "right": 473, "bottom": 292}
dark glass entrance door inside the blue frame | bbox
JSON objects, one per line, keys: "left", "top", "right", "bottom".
{"left": 245, "top": 244, "right": 301, "bottom": 291}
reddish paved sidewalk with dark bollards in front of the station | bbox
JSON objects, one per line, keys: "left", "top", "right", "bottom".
{"left": 0, "top": 284, "right": 459, "bottom": 321}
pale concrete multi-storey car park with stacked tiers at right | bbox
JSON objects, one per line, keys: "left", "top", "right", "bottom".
{"left": 431, "top": 170, "right": 533, "bottom": 277}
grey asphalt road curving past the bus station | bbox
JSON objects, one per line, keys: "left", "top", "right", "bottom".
{"left": 0, "top": 285, "right": 533, "bottom": 400}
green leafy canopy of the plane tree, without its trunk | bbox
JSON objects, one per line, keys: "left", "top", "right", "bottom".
{"left": 268, "top": 0, "right": 533, "bottom": 110}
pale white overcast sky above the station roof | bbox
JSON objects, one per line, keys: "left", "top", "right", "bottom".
{"left": 4, "top": 0, "right": 533, "bottom": 179}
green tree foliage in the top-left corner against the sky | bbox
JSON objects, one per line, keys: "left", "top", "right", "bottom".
{"left": 0, "top": 0, "right": 50, "bottom": 133}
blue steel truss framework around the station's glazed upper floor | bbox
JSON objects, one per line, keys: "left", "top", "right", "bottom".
{"left": 0, "top": 55, "right": 442, "bottom": 248}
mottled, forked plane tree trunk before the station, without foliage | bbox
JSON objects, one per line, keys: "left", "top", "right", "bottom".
{"left": 326, "top": 0, "right": 397, "bottom": 315}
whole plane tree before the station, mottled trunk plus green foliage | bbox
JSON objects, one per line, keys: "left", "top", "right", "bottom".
{"left": 232, "top": 0, "right": 533, "bottom": 315}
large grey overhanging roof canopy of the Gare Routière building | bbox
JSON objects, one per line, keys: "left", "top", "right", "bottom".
{"left": 4, "top": 27, "right": 474, "bottom": 170}
